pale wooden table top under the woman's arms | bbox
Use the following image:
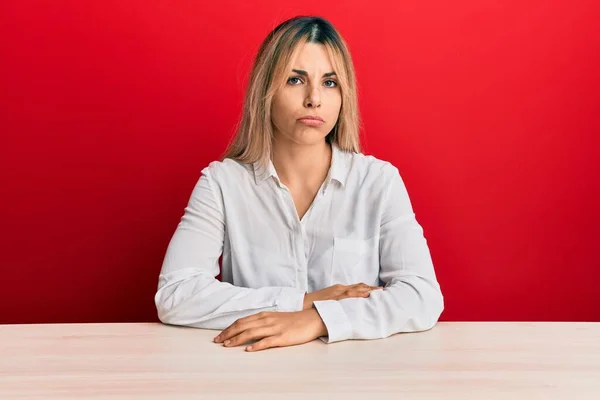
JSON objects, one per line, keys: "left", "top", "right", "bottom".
{"left": 0, "top": 322, "right": 600, "bottom": 400}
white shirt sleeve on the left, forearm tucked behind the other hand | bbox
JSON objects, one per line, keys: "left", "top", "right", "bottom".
{"left": 154, "top": 162, "right": 305, "bottom": 329}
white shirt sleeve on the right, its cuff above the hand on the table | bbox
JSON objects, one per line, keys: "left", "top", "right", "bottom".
{"left": 314, "top": 164, "right": 444, "bottom": 343}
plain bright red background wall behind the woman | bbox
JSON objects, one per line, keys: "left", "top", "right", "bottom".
{"left": 0, "top": 0, "right": 600, "bottom": 323}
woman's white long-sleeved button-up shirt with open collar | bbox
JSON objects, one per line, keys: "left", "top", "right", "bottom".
{"left": 155, "top": 145, "right": 444, "bottom": 343}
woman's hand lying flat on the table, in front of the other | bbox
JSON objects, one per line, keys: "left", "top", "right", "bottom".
{"left": 214, "top": 308, "right": 327, "bottom": 351}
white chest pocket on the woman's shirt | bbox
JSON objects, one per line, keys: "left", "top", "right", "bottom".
{"left": 331, "top": 235, "right": 379, "bottom": 285}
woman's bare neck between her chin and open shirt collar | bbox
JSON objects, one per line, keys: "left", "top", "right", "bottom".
{"left": 273, "top": 139, "right": 332, "bottom": 186}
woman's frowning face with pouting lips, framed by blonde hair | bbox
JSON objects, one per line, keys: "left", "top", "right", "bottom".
{"left": 271, "top": 43, "right": 342, "bottom": 145}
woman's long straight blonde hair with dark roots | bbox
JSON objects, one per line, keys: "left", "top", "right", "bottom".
{"left": 223, "top": 16, "right": 361, "bottom": 166}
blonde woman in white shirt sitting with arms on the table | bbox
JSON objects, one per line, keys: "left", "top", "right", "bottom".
{"left": 155, "top": 17, "right": 444, "bottom": 351}
